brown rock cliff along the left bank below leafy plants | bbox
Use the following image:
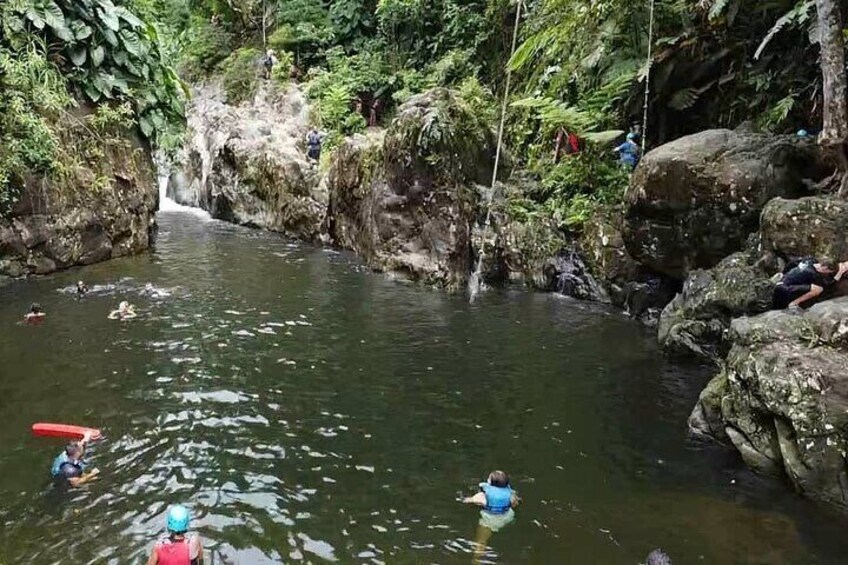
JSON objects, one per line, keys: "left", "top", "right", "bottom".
{"left": 0, "top": 109, "right": 158, "bottom": 277}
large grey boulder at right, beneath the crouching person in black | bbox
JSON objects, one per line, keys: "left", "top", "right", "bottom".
{"left": 689, "top": 298, "right": 848, "bottom": 507}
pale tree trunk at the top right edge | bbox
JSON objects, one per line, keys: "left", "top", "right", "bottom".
{"left": 816, "top": 0, "right": 848, "bottom": 196}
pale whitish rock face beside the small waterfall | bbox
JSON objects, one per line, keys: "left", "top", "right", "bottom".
{"left": 168, "top": 84, "right": 328, "bottom": 240}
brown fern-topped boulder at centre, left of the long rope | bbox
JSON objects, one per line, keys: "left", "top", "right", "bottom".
{"left": 327, "top": 88, "right": 504, "bottom": 288}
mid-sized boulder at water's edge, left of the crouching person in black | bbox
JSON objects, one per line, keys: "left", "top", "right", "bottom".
{"left": 658, "top": 253, "right": 774, "bottom": 361}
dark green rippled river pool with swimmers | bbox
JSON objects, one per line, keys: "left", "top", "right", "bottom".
{"left": 0, "top": 209, "right": 848, "bottom": 564}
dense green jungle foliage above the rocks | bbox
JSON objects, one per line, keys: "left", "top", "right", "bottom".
{"left": 0, "top": 0, "right": 844, "bottom": 228}
